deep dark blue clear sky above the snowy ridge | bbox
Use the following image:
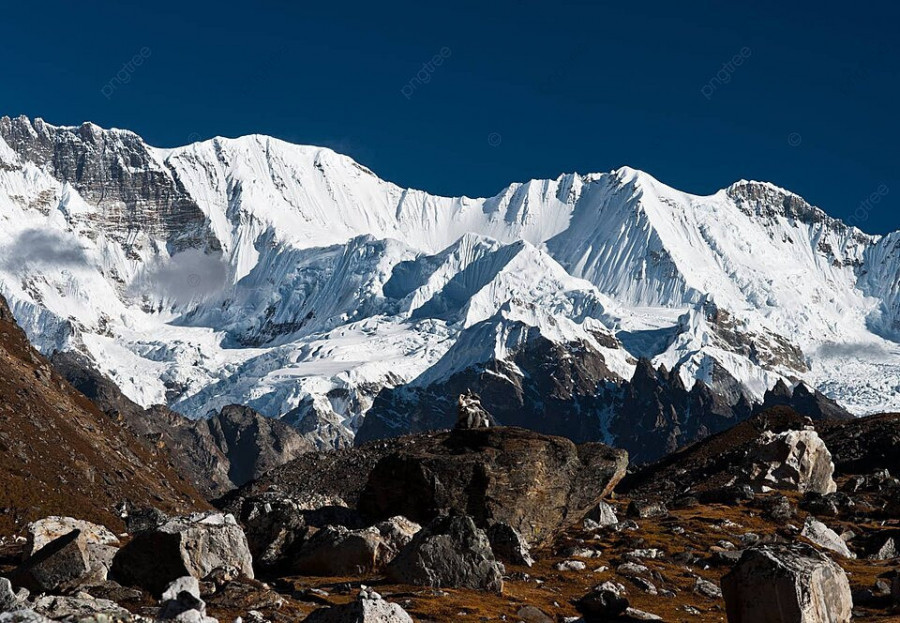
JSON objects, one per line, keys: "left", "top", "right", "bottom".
{"left": 0, "top": 0, "right": 900, "bottom": 233}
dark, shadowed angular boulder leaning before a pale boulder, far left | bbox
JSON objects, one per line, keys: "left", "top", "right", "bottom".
{"left": 11, "top": 530, "right": 91, "bottom": 593}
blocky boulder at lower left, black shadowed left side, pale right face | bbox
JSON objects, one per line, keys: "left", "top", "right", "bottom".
{"left": 111, "top": 513, "right": 253, "bottom": 595}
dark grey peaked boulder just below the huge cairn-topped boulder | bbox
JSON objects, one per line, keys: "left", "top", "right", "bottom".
{"left": 387, "top": 515, "right": 504, "bottom": 592}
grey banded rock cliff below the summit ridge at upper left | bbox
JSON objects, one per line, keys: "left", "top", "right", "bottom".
{"left": 0, "top": 117, "right": 220, "bottom": 252}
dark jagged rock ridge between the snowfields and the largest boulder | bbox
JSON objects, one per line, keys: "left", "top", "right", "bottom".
{"left": 356, "top": 348, "right": 753, "bottom": 463}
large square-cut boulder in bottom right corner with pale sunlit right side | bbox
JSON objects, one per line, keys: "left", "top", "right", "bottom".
{"left": 722, "top": 544, "right": 853, "bottom": 623}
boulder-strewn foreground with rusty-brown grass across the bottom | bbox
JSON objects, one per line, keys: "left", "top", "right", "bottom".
{"left": 0, "top": 400, "right": 900, "bottom": 623}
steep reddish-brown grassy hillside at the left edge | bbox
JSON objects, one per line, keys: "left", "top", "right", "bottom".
{"left": 0, "top": 297, "right": 207, "bottom": 534}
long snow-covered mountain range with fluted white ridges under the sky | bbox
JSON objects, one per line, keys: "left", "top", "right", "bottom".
{"left": 0, "top": 117, "right": 900, "bottom": 454}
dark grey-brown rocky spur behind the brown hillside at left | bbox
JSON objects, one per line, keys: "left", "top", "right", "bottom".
{"left": 53, "top": 352, "right": 314, "bottom": 499}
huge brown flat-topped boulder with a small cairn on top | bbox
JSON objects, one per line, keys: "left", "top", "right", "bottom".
{"left": 359, "top": 427, "right": 628, "bottom": 545}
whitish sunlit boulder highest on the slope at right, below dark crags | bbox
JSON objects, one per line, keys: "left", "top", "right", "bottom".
{"left": 744, "top": 430, "right": 837, "bottom": 494}
